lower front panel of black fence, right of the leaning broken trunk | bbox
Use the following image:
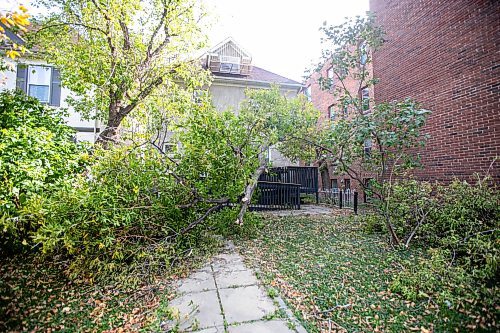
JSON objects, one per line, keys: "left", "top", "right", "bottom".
{"left": 250, "top": 181, "right": 300, "bottom": 211}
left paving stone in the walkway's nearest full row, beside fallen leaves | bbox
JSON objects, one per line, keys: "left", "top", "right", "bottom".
{"left": 169, "top": 290, "right": 224, "bottom": 330}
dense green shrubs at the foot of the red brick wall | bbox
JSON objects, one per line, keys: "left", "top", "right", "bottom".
{"left": 363, "top": 178, "right": 500, "bottom": 305}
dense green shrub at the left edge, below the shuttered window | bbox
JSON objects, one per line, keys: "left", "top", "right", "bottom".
{"left": 0, "top": 91, "right": 87, "bottom": 248}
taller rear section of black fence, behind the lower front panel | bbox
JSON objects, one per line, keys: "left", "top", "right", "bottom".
{"left": 259, "top": 166, "right": 319, "bottom": 201}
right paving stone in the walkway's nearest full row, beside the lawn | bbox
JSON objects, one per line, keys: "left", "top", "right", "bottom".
{"left": 219, "top": 286, "right": 277, "bottom": 324}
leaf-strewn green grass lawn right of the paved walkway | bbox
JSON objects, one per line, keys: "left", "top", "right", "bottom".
{"left": 237, "top": 217, "right": 498, "bottom": 332}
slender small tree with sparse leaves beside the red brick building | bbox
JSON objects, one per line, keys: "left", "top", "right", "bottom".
{"left": 309, "top": 16, "right": 429, "bottom": 244}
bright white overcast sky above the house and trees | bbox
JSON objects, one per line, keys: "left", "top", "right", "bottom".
{"left": 0, "top": 0, "right": 369, "bottom": 81}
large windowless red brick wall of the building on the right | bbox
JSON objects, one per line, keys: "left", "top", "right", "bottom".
{"left": 370, "top": 0, "right": 500, "bottom": 181}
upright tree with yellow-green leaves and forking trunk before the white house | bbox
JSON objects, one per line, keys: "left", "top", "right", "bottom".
{"left": 32, "top": 0, "right": 208, "bottom": 142}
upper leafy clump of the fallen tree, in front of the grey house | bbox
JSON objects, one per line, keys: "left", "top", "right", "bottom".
{"left": 177, "top": 86, "right": 318, "bottom": 202}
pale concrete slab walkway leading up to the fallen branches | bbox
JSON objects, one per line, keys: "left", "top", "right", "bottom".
{"left": 162, "top": 242, "right": 306, "bottom": 333}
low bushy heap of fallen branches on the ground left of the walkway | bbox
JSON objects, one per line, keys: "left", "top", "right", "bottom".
{"left": 29, "top": 147, "right": 227, "bottom": 283}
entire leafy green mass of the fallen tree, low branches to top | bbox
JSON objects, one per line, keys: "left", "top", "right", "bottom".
{"left": 2, "top": 87, "right": 315, "bottom": 283}
